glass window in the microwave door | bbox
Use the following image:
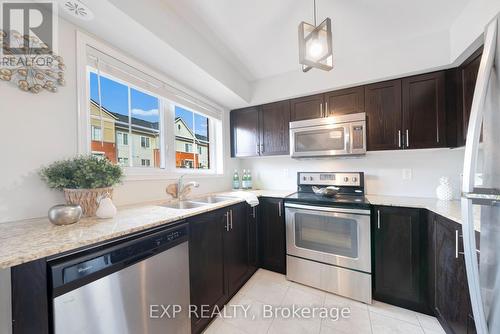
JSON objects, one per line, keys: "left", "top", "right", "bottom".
{"left": 295, "top": 127, "right": 345, "bottom": 152}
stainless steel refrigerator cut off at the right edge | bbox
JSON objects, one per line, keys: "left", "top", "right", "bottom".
{"left": 461, "top": 16, "right": 500, "bottom": 334}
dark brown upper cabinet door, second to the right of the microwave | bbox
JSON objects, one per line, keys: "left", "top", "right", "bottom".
{"left": 402, "top": 71, "right": 446, "bottom": 149}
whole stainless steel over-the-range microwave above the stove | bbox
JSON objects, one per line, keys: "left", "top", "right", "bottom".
{"left": 290, "top": 113, "right": 366, "bottom": 158}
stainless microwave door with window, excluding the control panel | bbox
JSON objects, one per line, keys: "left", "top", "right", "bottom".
{"left": 290, "top": 123, "right": 351, "bottom": 158}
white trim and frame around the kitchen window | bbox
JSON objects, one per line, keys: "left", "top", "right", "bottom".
{"left": 76, "top": 30, "right": 228, "bottom": 181}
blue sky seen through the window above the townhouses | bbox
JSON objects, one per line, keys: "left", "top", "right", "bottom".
{"left": 90, "top": 72, "right": 208, "bottom": 136}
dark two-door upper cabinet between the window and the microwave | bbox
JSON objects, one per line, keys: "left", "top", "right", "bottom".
{"left": 230, "top": 101, "right": 290, "bottom": 157}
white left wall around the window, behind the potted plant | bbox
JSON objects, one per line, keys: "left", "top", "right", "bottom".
{"left": 0, "top": 20, "right": 238, "bottom": 223}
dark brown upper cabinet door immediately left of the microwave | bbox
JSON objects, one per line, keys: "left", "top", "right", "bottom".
{"left": 260, "top": 101, "right": 290, "bottom": 155}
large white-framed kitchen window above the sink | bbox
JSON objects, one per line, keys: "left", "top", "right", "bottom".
{"left": 78, "top": 33, "right": 223, "bottom": 179}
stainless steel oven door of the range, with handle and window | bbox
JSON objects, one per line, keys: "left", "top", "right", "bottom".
{"left": 285, "top": 203, "right": 371, "bottom": 273}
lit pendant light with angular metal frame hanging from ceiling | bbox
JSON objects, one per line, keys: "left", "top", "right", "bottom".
{"left": 299, "top": 0, "right": 333, "bottom": 72}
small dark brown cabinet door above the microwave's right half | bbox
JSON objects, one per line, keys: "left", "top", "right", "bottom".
{"left": 324, "top": 86, "right": 365, "bottom": 117}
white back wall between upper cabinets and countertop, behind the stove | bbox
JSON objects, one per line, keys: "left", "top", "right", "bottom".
{"left": 241, "top": 148, "right": 464, "bottom": 198}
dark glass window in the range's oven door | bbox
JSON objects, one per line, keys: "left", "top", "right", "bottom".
{"left": 295, "top": 212, "right": 358, "bottom": 258}
